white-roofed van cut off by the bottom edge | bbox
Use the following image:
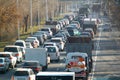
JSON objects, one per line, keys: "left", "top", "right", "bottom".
{"left": 36, "top": 72, "right": 75, "bottom": 80}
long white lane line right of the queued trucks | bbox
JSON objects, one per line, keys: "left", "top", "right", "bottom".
{"left": 90, "top": 31, "right": 102, "bottom": 80}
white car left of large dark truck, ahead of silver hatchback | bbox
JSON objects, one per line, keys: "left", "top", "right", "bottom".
{"left": 50, "top": 37, "right": 65, "bottom": 51}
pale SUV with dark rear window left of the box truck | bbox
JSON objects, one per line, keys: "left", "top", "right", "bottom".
{"left": 4, "top": 45, "right": 23, "bottom": 62}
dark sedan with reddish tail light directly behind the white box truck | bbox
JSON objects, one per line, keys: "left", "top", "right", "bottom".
{"left": 22, "top": 61, "right": 42, "bottom": 73}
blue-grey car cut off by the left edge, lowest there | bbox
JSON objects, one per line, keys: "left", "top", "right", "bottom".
{"left": 0, "top": 57, "right": 10, "bottom": 73}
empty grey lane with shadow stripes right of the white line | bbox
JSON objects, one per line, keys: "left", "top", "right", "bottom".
{"left": 91, "top": 31, "right": 120, "bottom": 80}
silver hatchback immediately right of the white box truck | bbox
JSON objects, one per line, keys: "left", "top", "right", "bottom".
{"left": 45, "top": 46, "right": 60, "bottom": 61}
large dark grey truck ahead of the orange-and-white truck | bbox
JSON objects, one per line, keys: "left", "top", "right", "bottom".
{"left": 66, "top": 36, "right": 94, "bottom": 79}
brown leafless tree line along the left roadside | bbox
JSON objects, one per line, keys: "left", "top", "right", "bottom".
{"left": 0, "top": 0, "right": 64, "bottom": 41}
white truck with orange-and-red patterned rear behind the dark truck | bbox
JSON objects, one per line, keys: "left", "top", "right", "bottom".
{"left": 65, "top": 52, "right": 89, "bottom": 80}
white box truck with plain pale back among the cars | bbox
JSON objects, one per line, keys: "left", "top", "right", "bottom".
{"left": 25, "top": 48, "right": 49, "bottom": 71}
